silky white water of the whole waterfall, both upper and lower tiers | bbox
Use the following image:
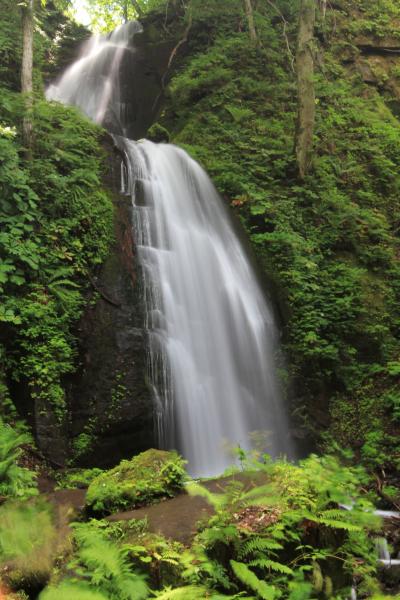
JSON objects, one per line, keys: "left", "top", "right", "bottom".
{"left": 48, "top": 21, "right": 292, "bottom": 476}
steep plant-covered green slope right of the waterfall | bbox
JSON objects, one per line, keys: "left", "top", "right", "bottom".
{"left": 160, "top": 0, "right": 400, "bottom": 475}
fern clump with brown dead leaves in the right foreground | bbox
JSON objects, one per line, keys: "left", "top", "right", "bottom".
{"left": 186, "top": 456, "right": 380, "bottom": 599}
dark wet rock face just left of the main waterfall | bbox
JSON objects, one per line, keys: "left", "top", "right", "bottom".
{"left": 67, "top": 141, "right": 153, "bottom": 466}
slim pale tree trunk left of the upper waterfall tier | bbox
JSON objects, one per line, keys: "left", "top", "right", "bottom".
{"left": 21, "top": 0, "right": 34, "bottom": 155}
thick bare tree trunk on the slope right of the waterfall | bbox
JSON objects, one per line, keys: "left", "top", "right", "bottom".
{"left": 296, "top": 0, "right": 316, "bottom": 179}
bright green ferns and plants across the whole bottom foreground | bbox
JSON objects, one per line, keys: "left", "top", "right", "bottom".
{"left": 0, "top": 456, "right": 395, "bottom": 600}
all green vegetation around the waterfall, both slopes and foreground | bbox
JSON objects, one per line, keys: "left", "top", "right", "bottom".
{"left": 0, "top": 0, "right": 400, "bottom": 600}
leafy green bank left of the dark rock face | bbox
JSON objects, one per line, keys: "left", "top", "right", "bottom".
{"left": 0, "top": 90, "right": 113, "bottom": 421}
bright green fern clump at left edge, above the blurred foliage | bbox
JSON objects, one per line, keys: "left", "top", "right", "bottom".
{"left": 0, "top": 418, "right": 37, "bottom": 501}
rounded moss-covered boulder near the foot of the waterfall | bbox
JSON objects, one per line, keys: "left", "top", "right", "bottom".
{"left": 86, "top": 450, "right": 187, "bottom": 515}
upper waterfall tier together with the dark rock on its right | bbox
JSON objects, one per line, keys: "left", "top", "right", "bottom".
{"left": 46, "top": 21, "right": 169, "bottom": 138}
